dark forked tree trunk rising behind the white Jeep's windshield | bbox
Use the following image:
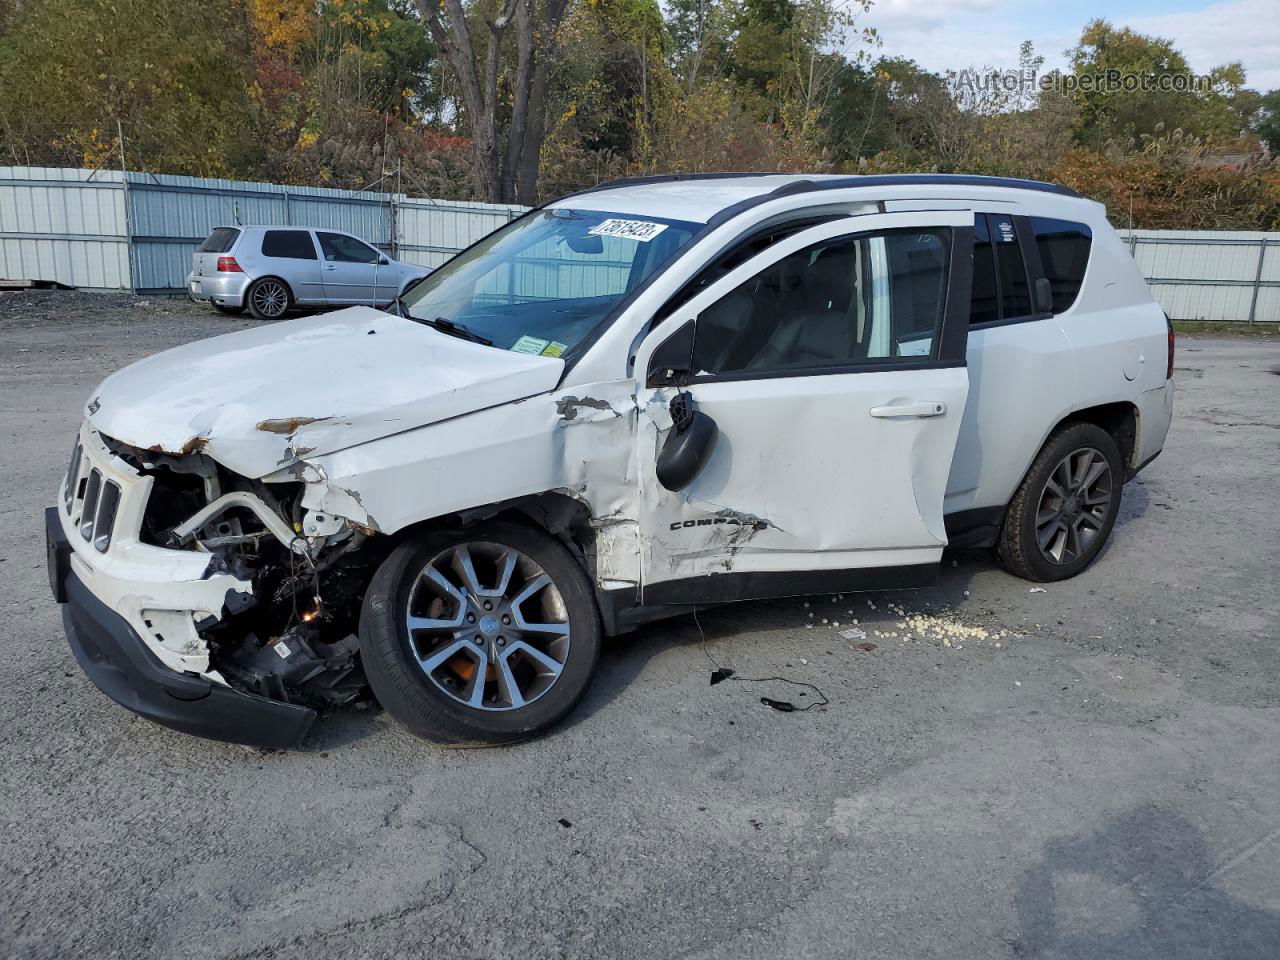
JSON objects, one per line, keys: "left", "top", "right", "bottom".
{"left": 417, "top": 0, "right": 568, "bottom": 202}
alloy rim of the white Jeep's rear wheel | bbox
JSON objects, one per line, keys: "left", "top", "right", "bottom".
{"left": 1036, "top": 447, "right": 1112, "bottom": 566}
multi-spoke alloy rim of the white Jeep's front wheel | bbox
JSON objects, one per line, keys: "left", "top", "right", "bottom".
{"left": 404, "top": 541, "right": 570, "bottom": 712}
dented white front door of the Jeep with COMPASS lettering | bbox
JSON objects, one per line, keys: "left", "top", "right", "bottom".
{"left": 635, "top": 211, "right": 973, "bottom": 603}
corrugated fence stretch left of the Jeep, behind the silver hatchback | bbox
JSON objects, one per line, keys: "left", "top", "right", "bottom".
{"left": 0, "top": 166, "right": 525, "bottom": 293}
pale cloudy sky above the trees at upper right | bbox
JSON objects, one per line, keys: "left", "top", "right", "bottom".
{"left": 850, "top": 0, "right": 1280, "bottom": 91}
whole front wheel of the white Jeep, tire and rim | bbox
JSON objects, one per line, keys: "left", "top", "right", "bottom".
{"left": 360, "top": 521, "right": 600, "bottom": 746}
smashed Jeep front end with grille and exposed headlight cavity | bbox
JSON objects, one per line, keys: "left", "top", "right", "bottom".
{"left": 50, "top": 424, "right": 381, "bottom": 745}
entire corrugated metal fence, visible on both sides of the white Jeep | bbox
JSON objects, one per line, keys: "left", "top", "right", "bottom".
{"left": 0, "top": 166, "right": 1280, "bottom": 323}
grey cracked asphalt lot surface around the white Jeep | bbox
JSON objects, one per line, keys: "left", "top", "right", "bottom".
{"left": 0, "top": 293, "right": 1280, "bottom": 960}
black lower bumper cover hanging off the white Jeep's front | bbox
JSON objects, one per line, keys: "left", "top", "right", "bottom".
{"left": 45, "top": 507, "right": 315, "bottom": 748}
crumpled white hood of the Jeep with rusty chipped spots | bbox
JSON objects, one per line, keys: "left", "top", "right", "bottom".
{"left": 86, "top": 307, "right": 564, "bottom": 477}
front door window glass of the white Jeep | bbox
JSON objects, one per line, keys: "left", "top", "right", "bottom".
{"left": 694, "top": 229, "right": 951, "bottom": 375}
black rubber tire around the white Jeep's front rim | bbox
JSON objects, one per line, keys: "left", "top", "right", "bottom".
{"left": 360, "top": 521, "right": 602, "bottom": 746}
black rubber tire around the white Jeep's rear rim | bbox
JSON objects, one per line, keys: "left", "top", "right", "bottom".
{"left": 996, "top": 422, "right": 1124, "bottom": 582}
